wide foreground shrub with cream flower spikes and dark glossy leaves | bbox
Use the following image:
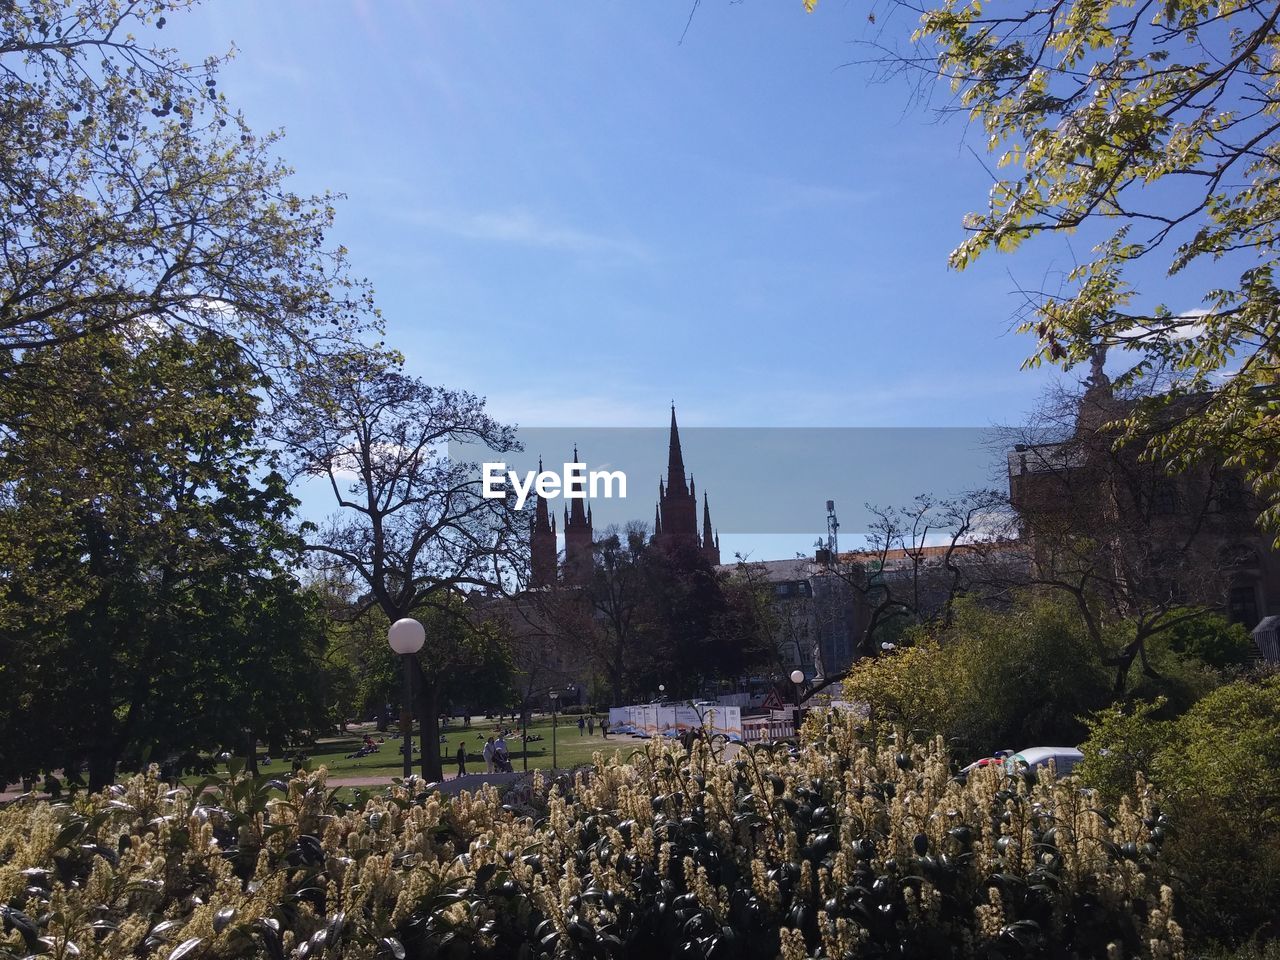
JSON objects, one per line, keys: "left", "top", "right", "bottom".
{"left": 0, "top": 716, "right": 1181, "bottom": 960}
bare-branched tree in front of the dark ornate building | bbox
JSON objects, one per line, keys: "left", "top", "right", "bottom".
{"left": 1005, "top": 381, "right": 1253, "bottom": 692}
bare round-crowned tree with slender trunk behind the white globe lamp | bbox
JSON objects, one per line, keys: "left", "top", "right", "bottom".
{"left": 275, "top": 351, "right": 527, "bottom": 780}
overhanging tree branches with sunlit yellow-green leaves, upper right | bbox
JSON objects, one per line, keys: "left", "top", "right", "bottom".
{"left": 824, "top": 0, "right": 1280, "bottom": 542}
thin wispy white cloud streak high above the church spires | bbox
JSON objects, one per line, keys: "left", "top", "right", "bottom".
{"left": 393, "top": 209, "right": 648, "bottom": 259}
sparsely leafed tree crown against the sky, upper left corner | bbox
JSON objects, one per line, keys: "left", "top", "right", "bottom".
{"left": 0, "top": 0, "right": 374, "bottom": 378}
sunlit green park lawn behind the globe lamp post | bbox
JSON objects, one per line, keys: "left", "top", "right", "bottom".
{"left": 304, "top": 717, "right": 644, "bottom": 780}
